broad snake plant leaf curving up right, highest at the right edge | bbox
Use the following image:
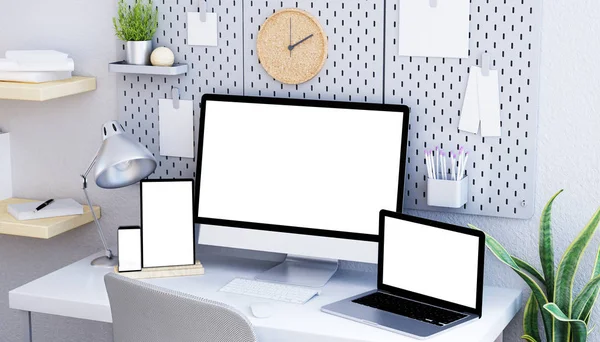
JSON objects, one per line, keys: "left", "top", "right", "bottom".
{"left": 553, "top": 209, "right": 600, "bottom": 342}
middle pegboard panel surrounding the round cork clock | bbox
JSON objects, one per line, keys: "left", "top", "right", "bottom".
{"left": 244, "top": 0, "right": 384, "bottom": 103}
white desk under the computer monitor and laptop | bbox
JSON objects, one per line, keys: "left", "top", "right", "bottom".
{"left": 9, "top": 255, "right": 521, "bottom": 342}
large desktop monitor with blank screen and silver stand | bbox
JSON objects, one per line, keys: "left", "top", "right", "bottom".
{"left": 195, "top": 95, "right": 409, "bottom": 286}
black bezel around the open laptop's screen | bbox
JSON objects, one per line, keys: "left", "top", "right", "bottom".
{"left": 377, "top": 210, "right": 485, "bottom": 317}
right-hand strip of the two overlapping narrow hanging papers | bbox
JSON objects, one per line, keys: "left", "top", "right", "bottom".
{"left": 477, "top": 68, "right": 502, "bottom": 137}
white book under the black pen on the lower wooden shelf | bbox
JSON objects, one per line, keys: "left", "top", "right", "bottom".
{"left": 8, "top": 198, "right": 83, "bottom": 221}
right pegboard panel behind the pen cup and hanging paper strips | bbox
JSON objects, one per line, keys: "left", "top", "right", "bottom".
{"left": 385, "top": 0, "right": 542, "bottom": 218}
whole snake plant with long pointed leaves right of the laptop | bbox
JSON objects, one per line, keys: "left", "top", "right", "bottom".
{"left": 469, "top": 190, "right": 600, "bottom": 342}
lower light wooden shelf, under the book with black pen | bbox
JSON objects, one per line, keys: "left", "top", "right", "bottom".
{"left": 0, "top": 198, "right": 101, "bottom": 239}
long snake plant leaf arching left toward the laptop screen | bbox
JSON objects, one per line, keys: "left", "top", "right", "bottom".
{"left": 469, "top": 224, "right": 552, "bottom": 339}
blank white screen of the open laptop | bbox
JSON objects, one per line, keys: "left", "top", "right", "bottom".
{"left": 382, "top": 217, "right": 479, "bottom": 309}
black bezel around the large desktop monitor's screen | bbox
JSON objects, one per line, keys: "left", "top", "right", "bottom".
{"left": 194, "top": 94, "right": 410, "bottom": 242}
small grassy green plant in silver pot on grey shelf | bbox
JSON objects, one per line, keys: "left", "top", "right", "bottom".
{"left": 113, "top": 0, "right": 158, "bottom": 65}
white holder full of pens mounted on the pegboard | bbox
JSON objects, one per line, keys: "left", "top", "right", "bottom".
{"left": 425, "top": 147, "right": 469, "bottom": 208}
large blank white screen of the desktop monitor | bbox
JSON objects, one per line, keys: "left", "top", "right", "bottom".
{"left": 198, "top": 101, "right": 405, "bottom": 236}
